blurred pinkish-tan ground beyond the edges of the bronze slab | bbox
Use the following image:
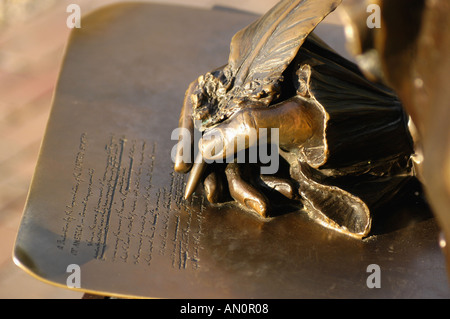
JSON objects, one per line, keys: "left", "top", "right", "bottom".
{"left": 0, "top": 0, "right": 347, "bottom": 299}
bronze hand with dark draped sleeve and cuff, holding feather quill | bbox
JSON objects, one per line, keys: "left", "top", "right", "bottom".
{"left": 175, "top": 0, "right": 415, "bottom": 238}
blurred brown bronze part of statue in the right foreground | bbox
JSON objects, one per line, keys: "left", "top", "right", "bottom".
{"left": 343, "top": 0, "right": 450, "bottom": 273}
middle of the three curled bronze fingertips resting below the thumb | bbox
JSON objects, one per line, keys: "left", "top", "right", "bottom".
{"left": 225, "top": 163, "right": 269, "bottom": 217}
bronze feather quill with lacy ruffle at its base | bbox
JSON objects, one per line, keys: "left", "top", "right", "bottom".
{"left": 192, "top": 0, "right": 341, "bottom": 131}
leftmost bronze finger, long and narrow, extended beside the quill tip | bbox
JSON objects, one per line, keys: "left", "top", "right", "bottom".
{"left": 174, "top": 81, "right": 197, "bottom": 173}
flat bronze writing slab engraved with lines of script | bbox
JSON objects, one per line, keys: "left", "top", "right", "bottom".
{"left": 14, "top": 4, "right": 450, "bottom": 298}
